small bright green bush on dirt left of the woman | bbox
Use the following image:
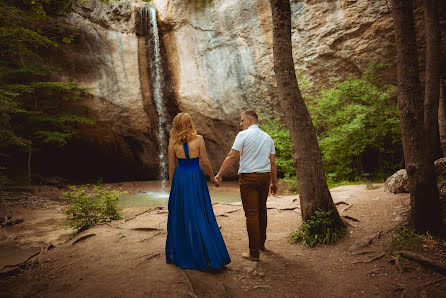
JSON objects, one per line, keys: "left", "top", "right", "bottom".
{"left": 63, "top": 185, "right": 125, "bottom": 232}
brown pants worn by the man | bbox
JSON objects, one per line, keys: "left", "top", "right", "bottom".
{"left": 239, "top": 173, "right": 270, "bottom": 257}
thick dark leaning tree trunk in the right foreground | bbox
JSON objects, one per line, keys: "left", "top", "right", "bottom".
{"left": 392, "top": 0, "right": 441, "bottom": 233}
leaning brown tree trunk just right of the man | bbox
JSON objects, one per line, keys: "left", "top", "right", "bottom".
{"left": 270, "top": 0, "right": 344, "bottom": 227}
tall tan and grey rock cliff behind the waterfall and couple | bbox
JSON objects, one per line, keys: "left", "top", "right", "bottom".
{"left": 42, "top": 0, "right": 442, "bottom": 179}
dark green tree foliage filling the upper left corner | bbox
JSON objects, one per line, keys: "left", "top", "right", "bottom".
{"left": 0, "top": 0, "right": 92, "bottom": 182}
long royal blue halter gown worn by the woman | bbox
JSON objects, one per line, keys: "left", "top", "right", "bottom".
{"left": 166, "top": 143, "right": 231, "bottom": 270}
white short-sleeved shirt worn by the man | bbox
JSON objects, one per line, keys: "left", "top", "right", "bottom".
{"left": 232, "top": 124, "right": 276, "bottom": 174}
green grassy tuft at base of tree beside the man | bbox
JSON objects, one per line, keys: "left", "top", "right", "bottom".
{"left": 291, "top": 210, "right": 345, "bottom": 247}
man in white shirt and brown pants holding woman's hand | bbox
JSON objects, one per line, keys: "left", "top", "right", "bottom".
{"left": 215, "top": 110, "right": 278, "bottom": 261}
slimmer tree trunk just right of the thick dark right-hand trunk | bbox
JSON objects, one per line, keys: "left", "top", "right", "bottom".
{"left": 424, "top": 0, "right": 441, "bottom": 160}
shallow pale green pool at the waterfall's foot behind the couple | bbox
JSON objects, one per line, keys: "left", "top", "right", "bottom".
{"left": 119, "top": 189, "right": 240, "bottom": 208}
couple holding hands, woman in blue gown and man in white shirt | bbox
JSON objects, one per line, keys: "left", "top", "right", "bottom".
{"left": 165, "top": 110, "right": 278, "bottom": 270}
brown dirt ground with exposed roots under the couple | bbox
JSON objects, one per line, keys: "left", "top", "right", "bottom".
{"left": 0, "top": 183, "right": 446, "bottom": 297}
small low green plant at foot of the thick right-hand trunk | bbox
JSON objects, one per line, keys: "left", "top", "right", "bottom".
{"left": 389, "top": 225, "right": 424, "bottom": 257}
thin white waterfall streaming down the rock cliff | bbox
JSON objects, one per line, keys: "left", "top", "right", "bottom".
{"left": 141, "top": 5, "right": 168, "bottom": 187}
